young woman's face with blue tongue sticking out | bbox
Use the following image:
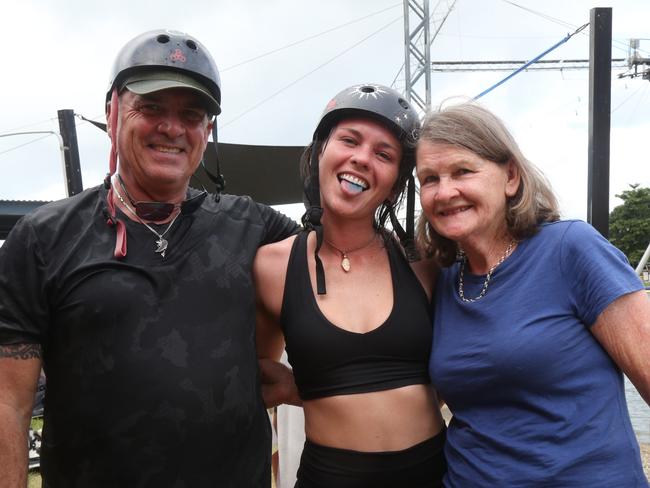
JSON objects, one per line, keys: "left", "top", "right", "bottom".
{"left": 319, "top": 118, "right": 402, "bottom": 224}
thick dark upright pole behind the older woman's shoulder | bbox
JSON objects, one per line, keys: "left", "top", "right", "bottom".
{"left": 587, "top": 8, "right": 612, "bottom": 238}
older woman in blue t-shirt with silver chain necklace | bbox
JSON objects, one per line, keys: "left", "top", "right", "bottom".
{"left": 417, "top": 103, "right": 650, "bottom": 487}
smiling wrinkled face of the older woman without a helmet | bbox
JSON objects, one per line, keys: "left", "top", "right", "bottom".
{"left": 416, "top": 140, "right": 520, "bottom": 249}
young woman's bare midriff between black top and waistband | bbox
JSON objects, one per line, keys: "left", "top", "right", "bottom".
{"left": 303, "top": 385, "right": 444, "bottom": 452}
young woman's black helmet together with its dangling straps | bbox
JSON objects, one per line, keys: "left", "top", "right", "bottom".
{"left": 302, "top": 83, "right": 420, "bottom": 295}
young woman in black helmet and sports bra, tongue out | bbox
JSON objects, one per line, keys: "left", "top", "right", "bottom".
{"left": 254, "top": 85, "right": 445, "bottom": 488}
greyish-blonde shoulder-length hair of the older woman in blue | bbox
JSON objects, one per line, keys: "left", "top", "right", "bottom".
{"left": 416, "top": 102, "right": 560, "bottom": 266}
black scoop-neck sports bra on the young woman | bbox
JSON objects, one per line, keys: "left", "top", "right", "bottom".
{"left": 280, "top": 232, "right": 432, "bottom": 400}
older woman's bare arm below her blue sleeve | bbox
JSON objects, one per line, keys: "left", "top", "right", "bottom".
{"left": 591, "top": 290, "right": 650, "bottom": 405}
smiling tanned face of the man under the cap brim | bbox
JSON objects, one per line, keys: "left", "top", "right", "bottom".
{"left": 108, "top": 88, "right": 212, "bottom": 201}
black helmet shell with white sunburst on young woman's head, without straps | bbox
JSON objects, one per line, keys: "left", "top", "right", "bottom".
{"left": 314, "top": 84, "right": 420, "bottom": 145}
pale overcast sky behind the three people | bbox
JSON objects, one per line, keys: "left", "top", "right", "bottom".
{"left": 0, "top": 0, "right": 650, "bottom": 225}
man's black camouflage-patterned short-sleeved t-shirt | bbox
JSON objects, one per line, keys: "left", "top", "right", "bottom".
{"left": 0, "top": 187, "right": 295, "bottom": 488}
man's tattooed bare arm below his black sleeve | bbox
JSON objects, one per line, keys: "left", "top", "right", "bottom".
{"left": 0, "top": 344, "right": 41, "bottom": 488}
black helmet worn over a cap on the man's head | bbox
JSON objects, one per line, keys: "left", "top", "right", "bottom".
{"left": 106, "top": 29, "right": 221, "bottom": 115}
